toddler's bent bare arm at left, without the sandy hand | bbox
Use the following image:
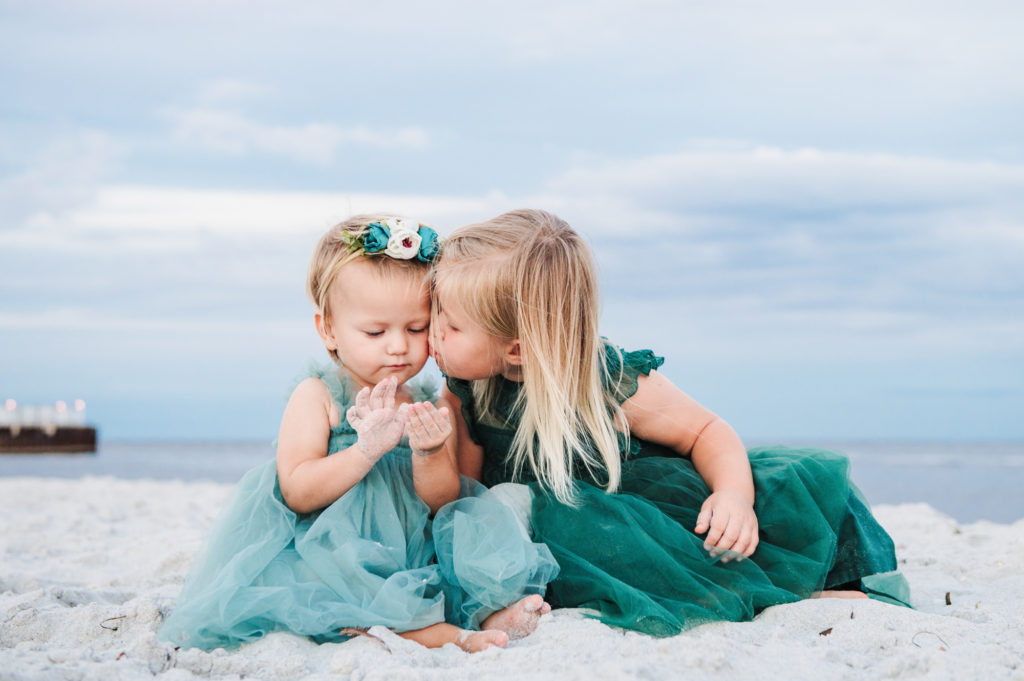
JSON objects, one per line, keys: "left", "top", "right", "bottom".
{"left": 278, "top": 378, "right": 373, "bottom": 513}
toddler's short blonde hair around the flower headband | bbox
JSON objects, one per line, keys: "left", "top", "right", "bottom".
{"left": 306, "top": 213, "right": 430, "bottom": 361}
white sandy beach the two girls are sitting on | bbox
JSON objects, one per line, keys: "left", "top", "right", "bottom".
{"left": 0, "top": 478, "right": 1024, "bottom": 681}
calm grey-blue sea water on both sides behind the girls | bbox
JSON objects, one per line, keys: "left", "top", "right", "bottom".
{"left": 0, "top": 440, "right": 1024, "bottom": 522}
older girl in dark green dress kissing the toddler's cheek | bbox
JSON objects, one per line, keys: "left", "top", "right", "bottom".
{"left": 432, "top": 210, "right": 906, "bottom": 635}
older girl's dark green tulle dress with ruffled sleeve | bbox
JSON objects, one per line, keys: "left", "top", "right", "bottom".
{"left": 447, "top": 345, "right": 909, "bottom": 636}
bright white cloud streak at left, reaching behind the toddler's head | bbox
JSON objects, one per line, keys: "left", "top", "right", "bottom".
{"left": 0, "top": 184, "right": 510, "bottom": 256}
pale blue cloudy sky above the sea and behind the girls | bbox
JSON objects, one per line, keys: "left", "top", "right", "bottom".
{"left": 0, "top": 0, "right": 1024, "bottom": 441}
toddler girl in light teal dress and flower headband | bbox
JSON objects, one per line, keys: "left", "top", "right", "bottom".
{"left": 160, "top": 215, "right": 558, "bottom": 651}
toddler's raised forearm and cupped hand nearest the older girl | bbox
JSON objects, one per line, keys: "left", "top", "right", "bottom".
{"left": 406, "top": 402, "right": 459, "bottom": 513}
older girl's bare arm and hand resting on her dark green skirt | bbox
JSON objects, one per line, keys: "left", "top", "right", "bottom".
{"left": 623, "top": 372, "right": 758, "bottom": 556}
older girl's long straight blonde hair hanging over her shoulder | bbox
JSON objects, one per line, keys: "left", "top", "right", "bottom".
{"left": 432, "top": 209, "right": 628, "bottom": 503}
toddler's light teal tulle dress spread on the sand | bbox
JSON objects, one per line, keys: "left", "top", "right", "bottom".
{"left": 159, "top": 367, "right": 558, "bottom": 650}
